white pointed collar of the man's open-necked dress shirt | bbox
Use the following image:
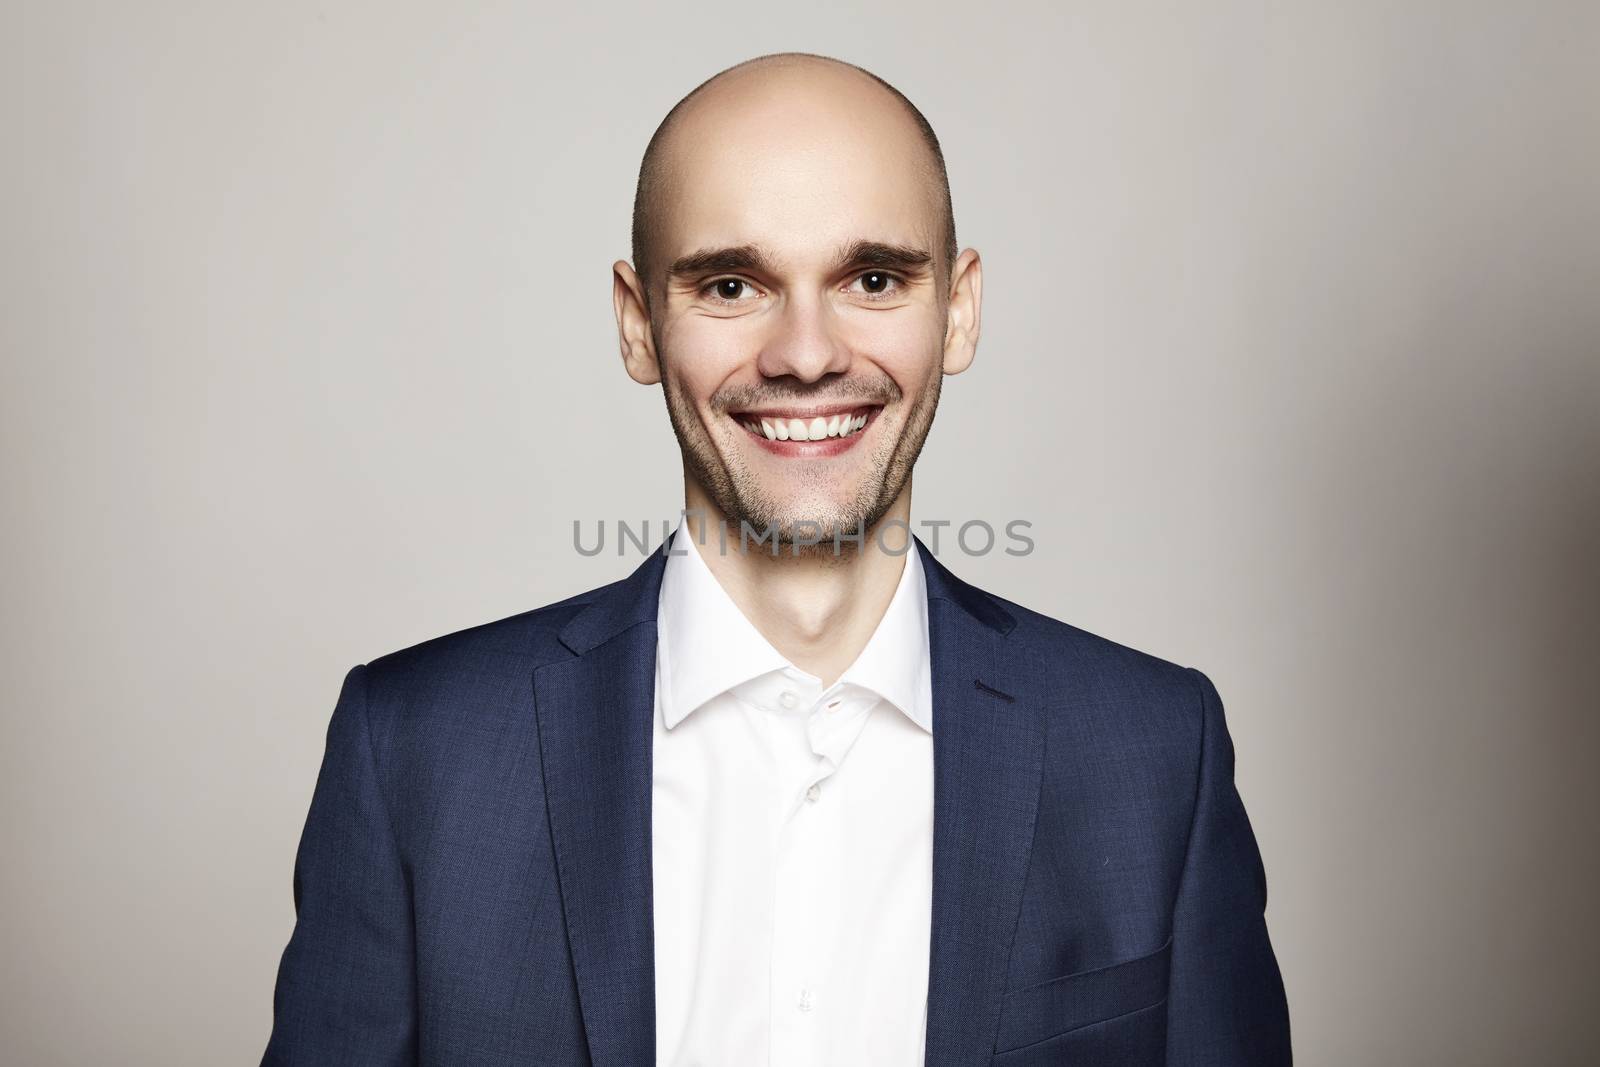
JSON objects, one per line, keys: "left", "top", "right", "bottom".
{"left": 656, "top": 522, "right": 933, "bottom": 733}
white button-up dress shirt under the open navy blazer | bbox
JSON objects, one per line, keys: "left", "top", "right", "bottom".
{"left": 651, "top": 525, "right": 933, "bottom": 1067}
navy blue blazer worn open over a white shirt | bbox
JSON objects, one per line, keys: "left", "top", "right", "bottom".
{"left": 262, "top": 541, "right": 1290, "bottom": 1067}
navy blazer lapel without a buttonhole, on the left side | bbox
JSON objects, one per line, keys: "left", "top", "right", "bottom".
{"left": 533, "top": 552, "right": 666, "bottom": 1067}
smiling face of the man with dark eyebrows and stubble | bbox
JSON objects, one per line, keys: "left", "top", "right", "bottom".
{"left": 620, "top": 70, "right": 958, "bottom": 542}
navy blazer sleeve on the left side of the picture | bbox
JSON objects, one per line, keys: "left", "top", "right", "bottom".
{"left": 261, "top": 665, "right": 416, "bottom": 1067}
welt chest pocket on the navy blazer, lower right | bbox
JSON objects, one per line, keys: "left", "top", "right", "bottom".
{"left": 995, "top": 937, "right": 1173, "bottom": 1053}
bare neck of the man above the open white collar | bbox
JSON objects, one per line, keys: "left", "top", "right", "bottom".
{"left": 683, "top": 483, "right": 917, "bottom": 685}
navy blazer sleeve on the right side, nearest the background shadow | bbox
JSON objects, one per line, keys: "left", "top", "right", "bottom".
{"left": 1166, "top": 667, "right": 1291, "bottom": 1067}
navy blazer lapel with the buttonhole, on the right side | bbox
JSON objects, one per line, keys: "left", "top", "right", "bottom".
{"left": 917, "top": 537, "right": 1045, "bottom": 1067}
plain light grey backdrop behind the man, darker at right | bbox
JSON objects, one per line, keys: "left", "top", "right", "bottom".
{"left": 0, "top": 2, "right": 1600, "bottom": 1064}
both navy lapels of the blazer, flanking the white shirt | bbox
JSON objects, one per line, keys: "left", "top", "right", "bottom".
{"left": 533, "top": 537, "right": 1045, "bottom": 1067}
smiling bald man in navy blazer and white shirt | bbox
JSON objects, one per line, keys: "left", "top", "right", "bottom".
{"left": 266, "top": 54, "right": 1290, "bottom": 1067}
